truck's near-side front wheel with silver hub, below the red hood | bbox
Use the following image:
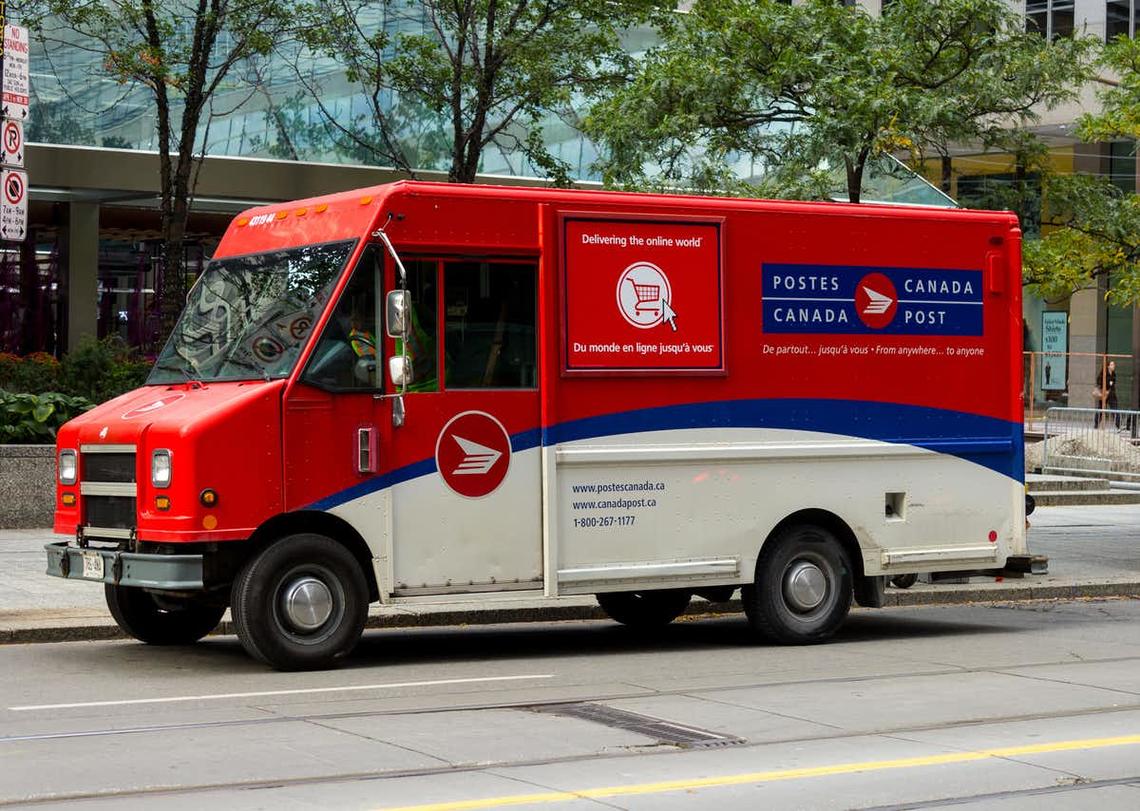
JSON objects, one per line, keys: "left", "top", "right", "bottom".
{"left": 230, "top": 534, "right": 368, "bottom": 671}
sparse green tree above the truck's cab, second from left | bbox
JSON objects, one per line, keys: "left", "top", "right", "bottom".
{"left": 299, "top": 0, "right": 671, "bottom": 183}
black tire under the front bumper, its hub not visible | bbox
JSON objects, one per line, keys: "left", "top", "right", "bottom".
{"left": 103, "top": 583, "right": 226, "bottom": 644}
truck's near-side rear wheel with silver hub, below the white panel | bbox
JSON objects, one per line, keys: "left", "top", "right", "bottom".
{"left": 741, "top": 525, "right": 854, "bottom": 644}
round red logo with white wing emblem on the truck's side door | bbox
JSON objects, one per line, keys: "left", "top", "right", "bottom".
{"left": 435, "top": 411, "right": 511, "bottom": 498}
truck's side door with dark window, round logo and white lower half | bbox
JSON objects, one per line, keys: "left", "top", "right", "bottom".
{"left": 390, "top": 258, "right": 543, "bottom": 595}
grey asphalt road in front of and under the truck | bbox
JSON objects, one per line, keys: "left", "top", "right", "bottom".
{"left": 0, "top": 600, "right": 1140, "bottom": 811}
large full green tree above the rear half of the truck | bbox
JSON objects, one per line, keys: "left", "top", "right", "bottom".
{"left": 587, "top": 0, "right": 1090, "bottom": 202}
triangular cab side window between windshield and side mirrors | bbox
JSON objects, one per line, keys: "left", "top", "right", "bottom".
{"left": 301, "top": 245, "right": 381, "bottom": 391}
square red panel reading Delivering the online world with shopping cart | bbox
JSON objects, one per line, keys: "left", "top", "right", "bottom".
{"left": 562, "top": 214, "right": 724, "bottom": 373}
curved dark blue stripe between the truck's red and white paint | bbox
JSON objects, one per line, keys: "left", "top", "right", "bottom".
{"left": 309, "top": 399, "right": 1025, "bottom": 510}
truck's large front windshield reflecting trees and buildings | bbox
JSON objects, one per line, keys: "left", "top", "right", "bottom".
{"left": 147, "top": 241, "right": 355, "bottom": 384}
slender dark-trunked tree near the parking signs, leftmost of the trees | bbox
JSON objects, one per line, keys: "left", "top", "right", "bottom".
{"left": 22, "top": 0, "right": 291, "bottom": 339}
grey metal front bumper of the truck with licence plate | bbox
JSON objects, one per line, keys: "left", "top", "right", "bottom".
{"left": 43, "top": 541, "right": 203, "bottom": 591}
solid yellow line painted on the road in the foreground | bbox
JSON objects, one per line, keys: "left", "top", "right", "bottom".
{"left": 380, "top": 735, "right": 1140, "bottom": 811}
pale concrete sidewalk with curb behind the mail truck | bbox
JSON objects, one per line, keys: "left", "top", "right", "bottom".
{"left": 0, "top": 505, "right": 1140, "bottom": 643}
